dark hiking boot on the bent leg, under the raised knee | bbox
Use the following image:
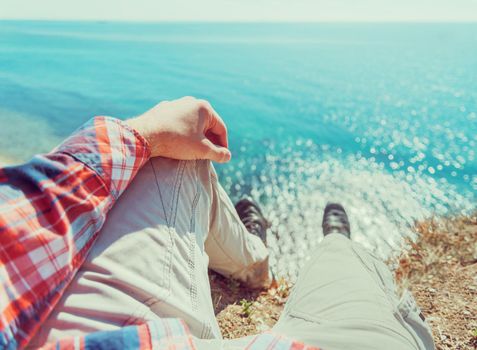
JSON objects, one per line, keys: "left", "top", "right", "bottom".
{"left": 235, "top": 197, "right": 270, "bottom": 246}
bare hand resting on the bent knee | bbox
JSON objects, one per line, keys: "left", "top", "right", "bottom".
{"left": 126, "top": 97, "right": 231, "bottom": 163}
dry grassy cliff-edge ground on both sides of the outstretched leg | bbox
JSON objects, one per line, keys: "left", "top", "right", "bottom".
{"left": 211, "top": 216, "right": 477, "bottom": 350}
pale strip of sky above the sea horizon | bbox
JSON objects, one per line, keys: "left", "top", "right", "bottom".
{"left": 0, "top": 0, "right": 477, "bottom": 22}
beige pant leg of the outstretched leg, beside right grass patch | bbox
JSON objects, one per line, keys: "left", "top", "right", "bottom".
{"left": 273, "top": 234, "right": 428, "bottom": 350}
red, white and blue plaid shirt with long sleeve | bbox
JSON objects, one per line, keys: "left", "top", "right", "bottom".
{"left": 0, "top": 117, "right": 320, "bottom": 349}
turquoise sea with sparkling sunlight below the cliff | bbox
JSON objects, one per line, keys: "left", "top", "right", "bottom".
{"left": 0, "top": 21, "right": 477, "bottom": 275}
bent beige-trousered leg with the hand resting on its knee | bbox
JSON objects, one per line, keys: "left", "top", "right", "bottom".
{"left": 30, "top": 158, "right": 268, "bottom": 346}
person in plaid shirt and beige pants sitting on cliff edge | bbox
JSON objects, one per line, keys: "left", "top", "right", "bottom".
{"left": 0, "top": 97, "right": 433, "bottom": 349}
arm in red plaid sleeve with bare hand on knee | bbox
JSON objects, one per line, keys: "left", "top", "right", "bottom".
{"left": 0, "top": 98, "right": 230, "bottom": 348}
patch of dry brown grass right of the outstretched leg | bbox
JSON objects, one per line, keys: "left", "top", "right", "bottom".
{"left": 396, "top": 216, "right": 477, "bottom": 350}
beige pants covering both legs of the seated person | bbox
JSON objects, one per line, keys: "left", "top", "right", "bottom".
{"left": 30, "top": 158, "right": 428, "bottom": 349}
